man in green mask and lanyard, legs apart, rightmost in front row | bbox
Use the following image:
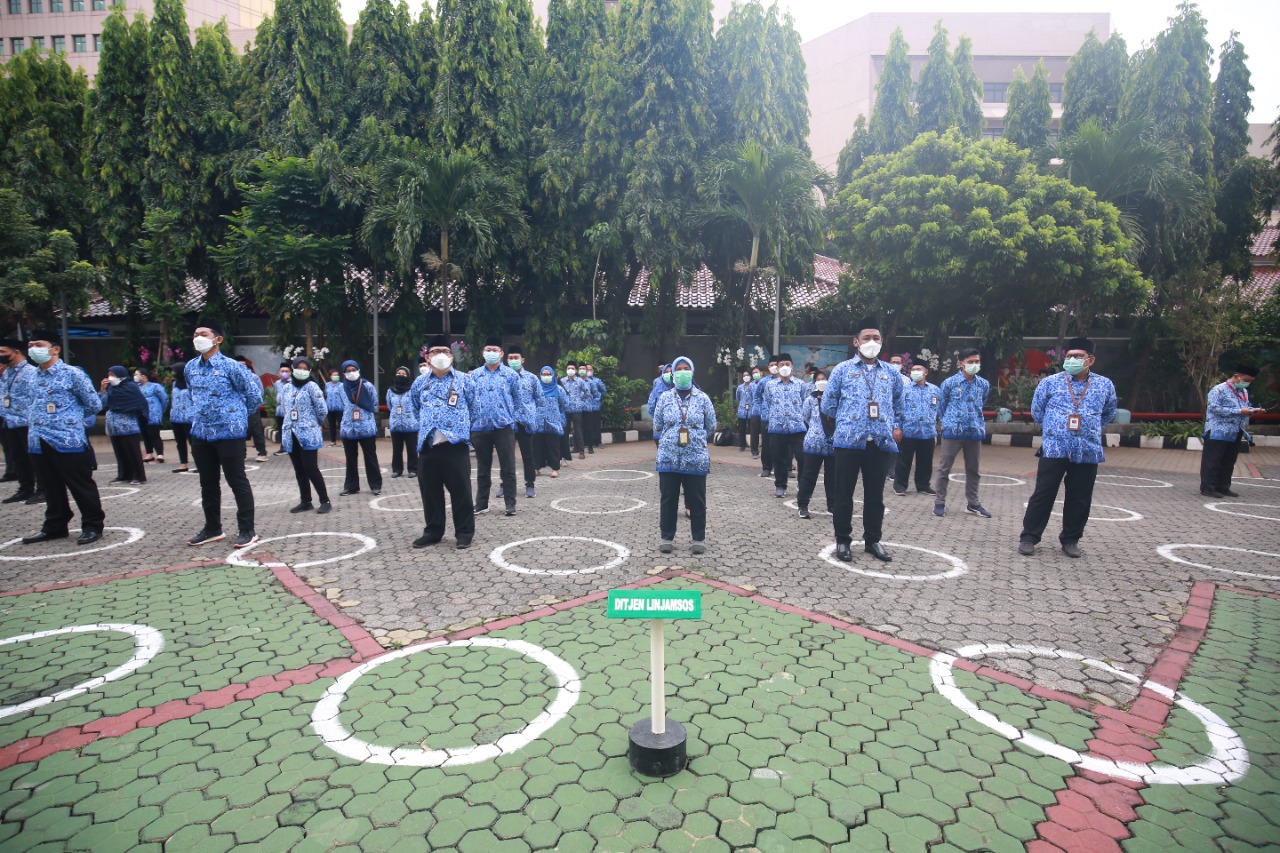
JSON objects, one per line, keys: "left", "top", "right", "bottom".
{"left": 1018, "top": 338, "right": 1116, "bottom": 557}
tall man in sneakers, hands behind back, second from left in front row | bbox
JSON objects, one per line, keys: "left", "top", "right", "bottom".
{"left": 184, "top": 320, "right": 262, "bottom": 549}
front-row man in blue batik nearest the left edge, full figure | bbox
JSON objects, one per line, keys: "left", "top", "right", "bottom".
{"left": 22, "top": 332, "right": 106, "bottom": 544}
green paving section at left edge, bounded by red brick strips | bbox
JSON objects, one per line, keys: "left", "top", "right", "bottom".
{"left": 0, "top": 566, "right": 351, "bottom": 745}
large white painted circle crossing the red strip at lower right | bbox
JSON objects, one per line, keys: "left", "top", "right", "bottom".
{"left": 929, "top": 643, "right": 1249, "bottom": 785}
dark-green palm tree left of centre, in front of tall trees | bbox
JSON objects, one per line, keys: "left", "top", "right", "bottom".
{"left": 360, "top": 151, "right": 527, "bottom": 334}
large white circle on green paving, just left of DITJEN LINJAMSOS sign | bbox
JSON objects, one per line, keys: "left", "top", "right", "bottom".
{"left": 311, "top": 637, "right": 582, "bottom": 767}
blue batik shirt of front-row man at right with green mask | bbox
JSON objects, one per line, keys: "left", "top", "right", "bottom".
{"left": 1032, "top": 373, "right": 1116, "bottom": 465}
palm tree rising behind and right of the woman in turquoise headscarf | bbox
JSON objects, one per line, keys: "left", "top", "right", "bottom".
{"left": 703, "top": 140, "right": 827, "bottom": 350}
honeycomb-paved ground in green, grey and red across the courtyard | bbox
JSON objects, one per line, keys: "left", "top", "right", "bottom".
{"left": 0, "top": 435, "right": 1280, "bottom": 850}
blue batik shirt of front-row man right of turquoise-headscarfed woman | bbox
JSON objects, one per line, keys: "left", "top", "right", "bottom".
{"left": 822, "top": 357, "right": 902, "bottom": 453}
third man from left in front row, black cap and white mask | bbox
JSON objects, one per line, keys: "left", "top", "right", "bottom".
{"left": 407, "top": 334, "right": 476, "bottom": 551}
